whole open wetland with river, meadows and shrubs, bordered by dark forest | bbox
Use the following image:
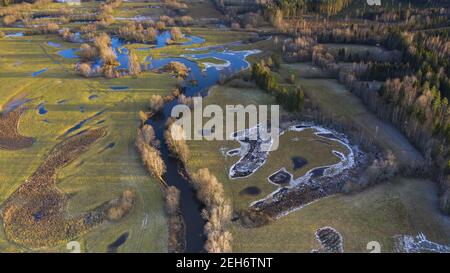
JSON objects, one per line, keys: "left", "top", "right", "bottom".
{"left": 0, "top": 0, "right": 450, "bottom": 253}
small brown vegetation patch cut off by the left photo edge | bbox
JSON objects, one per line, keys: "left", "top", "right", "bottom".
{"left": 0, "top": 108, "right": 33, "bottom": 150}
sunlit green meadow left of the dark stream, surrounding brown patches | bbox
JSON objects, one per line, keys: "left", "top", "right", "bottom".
{"left": 0, "top": 33, "right": 175, "bottom": 252}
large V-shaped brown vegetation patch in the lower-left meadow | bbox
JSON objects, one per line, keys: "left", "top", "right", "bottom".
{"left": 1, "top": 128, "right": 134, "bottom": 248}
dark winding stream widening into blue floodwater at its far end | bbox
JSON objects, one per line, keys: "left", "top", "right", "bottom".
{"left": 148, "top": 46, "right": 258, "bottom": 253}
